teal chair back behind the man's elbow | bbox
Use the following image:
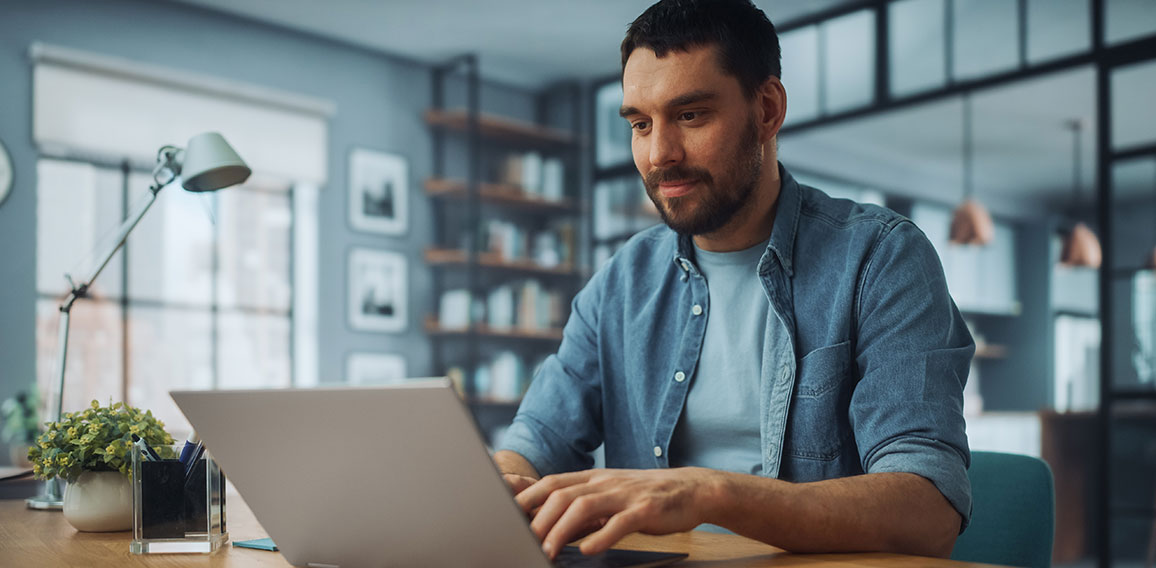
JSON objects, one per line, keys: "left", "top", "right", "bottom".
{"left": 951, "top": 451, "right": 1055, "bottom": 568}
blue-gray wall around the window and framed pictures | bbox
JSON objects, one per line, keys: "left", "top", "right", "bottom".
{"left": 0, "top": 0, "right": 534, "bottom": 463}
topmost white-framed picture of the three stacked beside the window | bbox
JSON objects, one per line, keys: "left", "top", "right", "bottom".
{"left": 349, "top": 148, "right": 409, "bottom": 235}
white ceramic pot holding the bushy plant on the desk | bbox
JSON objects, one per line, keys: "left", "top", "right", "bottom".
{"left": 64, "top": 471, "right": 133, "bottom": 532}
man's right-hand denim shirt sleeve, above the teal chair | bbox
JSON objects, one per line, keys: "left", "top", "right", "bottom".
{"left": 851, "top": 220, "right": 976, "bottom": 528}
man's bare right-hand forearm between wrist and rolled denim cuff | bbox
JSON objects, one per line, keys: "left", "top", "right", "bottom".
{"left": 704, "top": 472, "right": 961, "bottom": 558}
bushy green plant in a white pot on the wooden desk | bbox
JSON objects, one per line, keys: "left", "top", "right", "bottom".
{"left": 28, "top": 400, "right": 172, "bottom": 532}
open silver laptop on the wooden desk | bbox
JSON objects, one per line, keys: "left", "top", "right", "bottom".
{"left": 171, "top": 379, "right": 686, "bottom": 568}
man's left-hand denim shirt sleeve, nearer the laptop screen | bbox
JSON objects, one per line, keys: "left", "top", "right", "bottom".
{"left": 497, "top": 270, "right": 607, "bottom": 475}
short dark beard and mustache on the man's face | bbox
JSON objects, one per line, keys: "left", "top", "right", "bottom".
{"left": 643, "top": 118, "right": 763, "bottom": 236}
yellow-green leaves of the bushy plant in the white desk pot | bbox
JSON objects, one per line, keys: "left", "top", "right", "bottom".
{"left": 28, "top": 400, "right": 175, "bottom": 481}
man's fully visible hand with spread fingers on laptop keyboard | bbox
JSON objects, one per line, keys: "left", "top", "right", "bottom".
{"left": 506, "top": 467, "right": 716, "bottom": 560}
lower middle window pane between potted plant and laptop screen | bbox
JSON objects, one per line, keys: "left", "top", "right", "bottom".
{"left": 128, "top": 305, "right": 214, "bottom": 435}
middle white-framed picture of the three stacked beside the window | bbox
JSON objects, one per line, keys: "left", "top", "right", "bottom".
{"left": 349, "top": 249, "right": 409, "bottom": 332}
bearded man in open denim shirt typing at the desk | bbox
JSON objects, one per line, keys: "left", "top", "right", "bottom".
{"left": 494, "top": 0, "right": 975, "bottom": 556}
